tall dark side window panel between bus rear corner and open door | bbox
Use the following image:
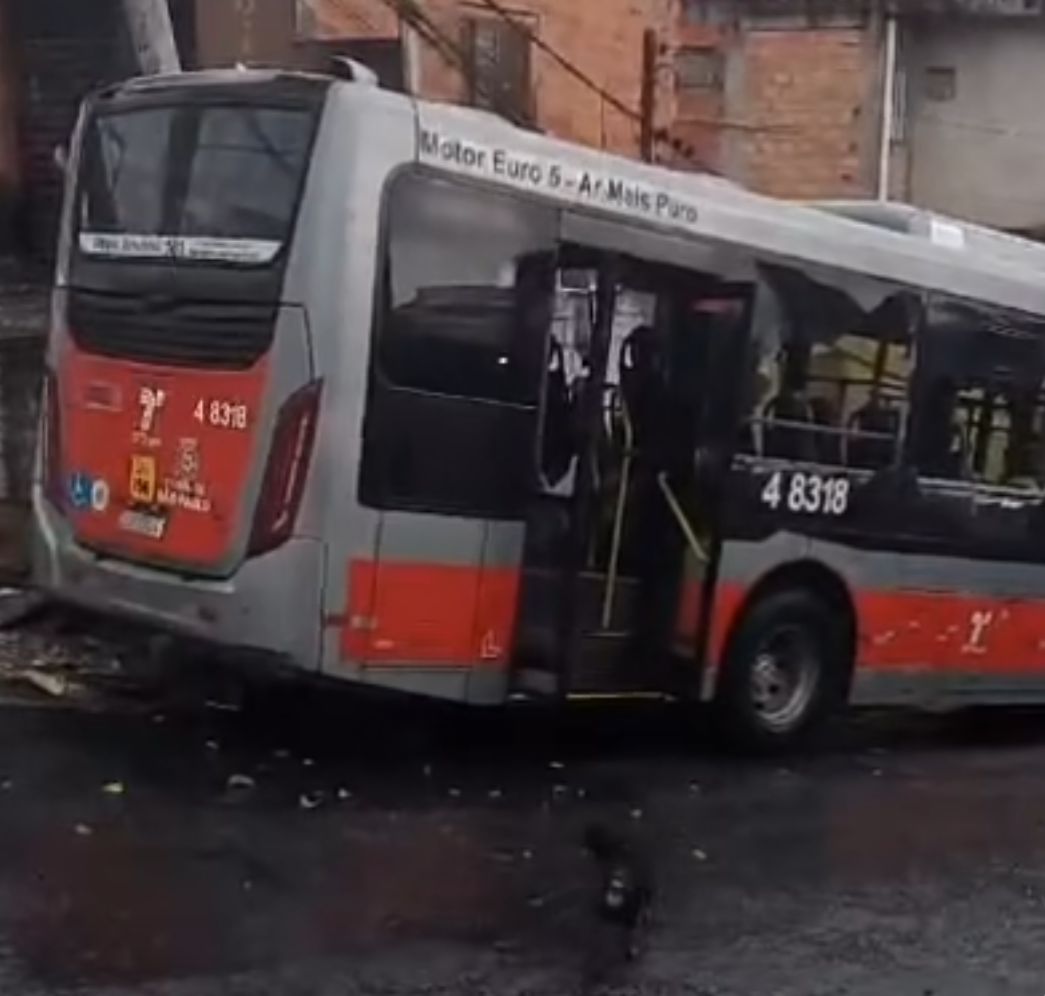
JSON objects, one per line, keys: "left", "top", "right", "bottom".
{"left": 359, "top": 173, "right": 556, "bottom": 518}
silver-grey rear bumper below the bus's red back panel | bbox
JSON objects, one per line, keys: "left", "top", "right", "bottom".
{"left": 31, "top": 488, "right": 323, "bottom": 671}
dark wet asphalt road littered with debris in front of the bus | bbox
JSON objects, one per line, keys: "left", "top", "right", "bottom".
{"left": 0, "top": 696, "right": 1045, "bottom": 996}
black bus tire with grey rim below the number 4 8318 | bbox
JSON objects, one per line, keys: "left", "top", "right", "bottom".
{"left": 715, "top": 587, "right": 851, "bottom": 752}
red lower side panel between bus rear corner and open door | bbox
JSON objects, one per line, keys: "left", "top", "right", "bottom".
{"left": 342, "top": 560, "right": 519, "bottom": 667}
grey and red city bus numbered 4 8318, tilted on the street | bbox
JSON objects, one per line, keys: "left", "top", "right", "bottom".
{"left": 32, "top": 69, "right": 1045, "bottom": 749}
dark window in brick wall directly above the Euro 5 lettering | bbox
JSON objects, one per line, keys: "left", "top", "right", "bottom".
{"left": 464, "top": 17, "right": 534, "bottom": 124}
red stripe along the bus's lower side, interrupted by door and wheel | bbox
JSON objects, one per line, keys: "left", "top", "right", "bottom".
{"left": 338, "top": 560, "right": 1045, "bottom": 674}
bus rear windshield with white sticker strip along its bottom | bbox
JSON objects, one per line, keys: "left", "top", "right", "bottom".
{"left": 78, "top": 105, "right": 315, "bottom": 265}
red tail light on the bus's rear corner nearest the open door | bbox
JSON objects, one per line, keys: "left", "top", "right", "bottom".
{"left": 250, "top": 380, "right": 323, "bottom": 556}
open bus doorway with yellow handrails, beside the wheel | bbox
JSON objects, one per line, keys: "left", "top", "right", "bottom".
{"left": 514, "top": 247, "right": 752, "bottom": 698}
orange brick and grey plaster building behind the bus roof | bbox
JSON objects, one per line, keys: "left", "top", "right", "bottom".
{"left": 292, "top": 0, "right": 1045, "bottom": 226}
